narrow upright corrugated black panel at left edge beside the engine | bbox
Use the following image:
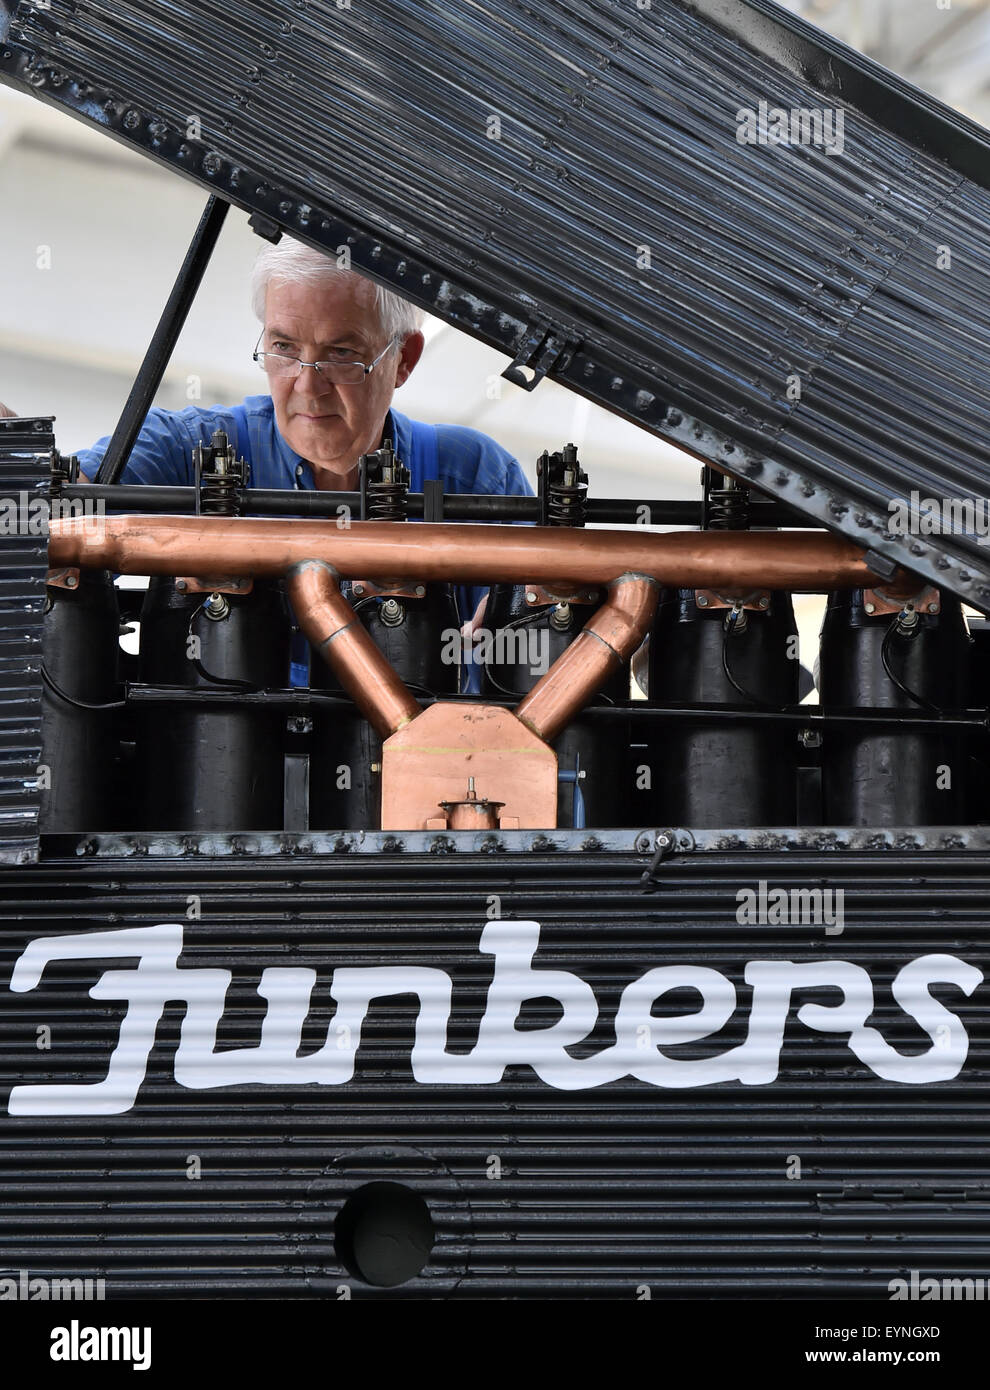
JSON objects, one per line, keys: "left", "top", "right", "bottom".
{"left": 0, "top": 418, "right": 47, "bottom": 863}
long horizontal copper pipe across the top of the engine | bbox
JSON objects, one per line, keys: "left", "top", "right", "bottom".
{"left": 49, "top": 517, "right": 897, "bottom": 594}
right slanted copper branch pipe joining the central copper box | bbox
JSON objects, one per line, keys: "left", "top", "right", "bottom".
{"left": 516, "top": 574, "right": 660, "bottom": 744}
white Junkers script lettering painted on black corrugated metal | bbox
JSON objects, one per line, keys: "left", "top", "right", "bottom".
{"left": 10, "top": 920, "right": 983, "bottom": 1115}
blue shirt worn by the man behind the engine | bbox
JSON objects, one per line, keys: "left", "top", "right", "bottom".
{"left": 76, "top": 396, "right": 533, "bottom": 685}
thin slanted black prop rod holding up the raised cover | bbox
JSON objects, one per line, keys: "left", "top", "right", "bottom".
{"left": 96, "top": 195, "right": 229, "bottom": 484}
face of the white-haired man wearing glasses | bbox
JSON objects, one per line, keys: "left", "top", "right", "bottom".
{"left": 261, "top": 277, "right": 423, "bottom": 488}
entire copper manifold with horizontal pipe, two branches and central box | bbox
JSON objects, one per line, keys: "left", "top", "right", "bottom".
{"left": 49, "top": 516, "right": 918, "bottom": 828}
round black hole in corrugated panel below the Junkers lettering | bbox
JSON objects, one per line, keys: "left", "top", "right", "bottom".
{"left": 334, "top": 1183, "right": 437, "bottom": 1289}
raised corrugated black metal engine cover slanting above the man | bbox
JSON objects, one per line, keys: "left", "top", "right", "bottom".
{"left": 0, "top": 0, "right": 990, "bottom": 610}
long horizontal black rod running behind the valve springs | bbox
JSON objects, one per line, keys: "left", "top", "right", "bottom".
{"left": 60, "top": 482, "right": 822, "bottom": 530}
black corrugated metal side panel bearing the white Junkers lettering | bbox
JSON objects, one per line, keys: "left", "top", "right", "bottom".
{"left": 0, "top": 849, "right": 990, "bottom": 1298}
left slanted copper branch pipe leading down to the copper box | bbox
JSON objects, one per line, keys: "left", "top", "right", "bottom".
{"left": 286, "top": 560, "right": 421, "bottom": 738}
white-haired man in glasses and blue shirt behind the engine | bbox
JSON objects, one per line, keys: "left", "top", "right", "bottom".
{"left": 66, "top": 238, "right": 531, "bottom": 496}
